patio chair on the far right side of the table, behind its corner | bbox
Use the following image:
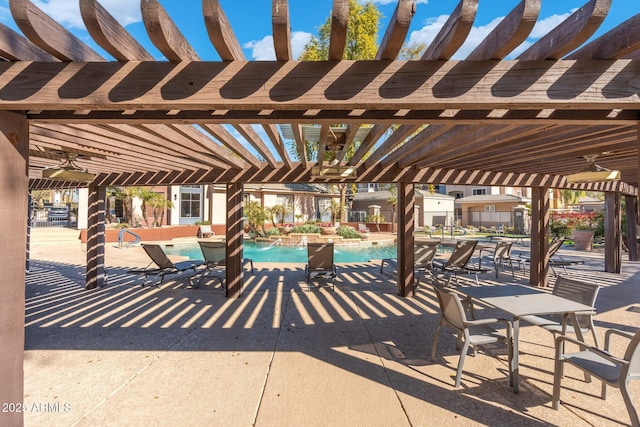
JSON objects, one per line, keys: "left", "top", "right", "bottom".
{"left": 520, "top": 276, "right": 600, "bottom": 347}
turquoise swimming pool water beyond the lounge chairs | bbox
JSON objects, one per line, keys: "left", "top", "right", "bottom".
{"left": 165, "top": 242, "right": 397, "bottom": 263}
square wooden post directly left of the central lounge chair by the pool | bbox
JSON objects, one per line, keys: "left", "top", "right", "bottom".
{"left": 226, "top": 183, "right": 244, "bottom": 298}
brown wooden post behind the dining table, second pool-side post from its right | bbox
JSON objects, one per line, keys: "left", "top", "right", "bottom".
{"left": 529, "top": 187, "right": 549, "bottom": 287}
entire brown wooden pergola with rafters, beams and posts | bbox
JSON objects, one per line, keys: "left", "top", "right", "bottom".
{"left": 0, "top": 0, "right": 640, "bottom": 422}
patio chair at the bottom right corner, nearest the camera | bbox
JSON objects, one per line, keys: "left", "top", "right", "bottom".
{"left": 552, "top": 329, "right": 640, "bottom": 427}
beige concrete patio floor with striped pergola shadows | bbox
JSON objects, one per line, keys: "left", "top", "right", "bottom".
{"left": 24, "top": 230, "right": 640, "bottom": 426}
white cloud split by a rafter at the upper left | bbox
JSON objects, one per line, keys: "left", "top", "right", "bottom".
{"left": 33, "top": 0, "right": 142, "bottom": 29}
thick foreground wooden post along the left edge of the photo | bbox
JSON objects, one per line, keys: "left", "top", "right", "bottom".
{"left": 0, "top": 111, "right": 29, "bottom": 426}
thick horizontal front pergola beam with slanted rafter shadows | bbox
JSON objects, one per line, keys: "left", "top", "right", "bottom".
{"left": 0, "top": 59, "right": 640, "bottom": 111}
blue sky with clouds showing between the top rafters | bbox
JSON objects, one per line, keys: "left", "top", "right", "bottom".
{"left": 0, "top": 0, "right": 640, "bottom": 61}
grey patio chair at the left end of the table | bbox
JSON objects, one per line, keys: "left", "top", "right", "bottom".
{"left": 431, "top": 285, "right": 513, "bottom": 388}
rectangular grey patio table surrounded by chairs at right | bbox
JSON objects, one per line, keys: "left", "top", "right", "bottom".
{"left": 454, "top": 284, "right": 593, "bottom": 393}
